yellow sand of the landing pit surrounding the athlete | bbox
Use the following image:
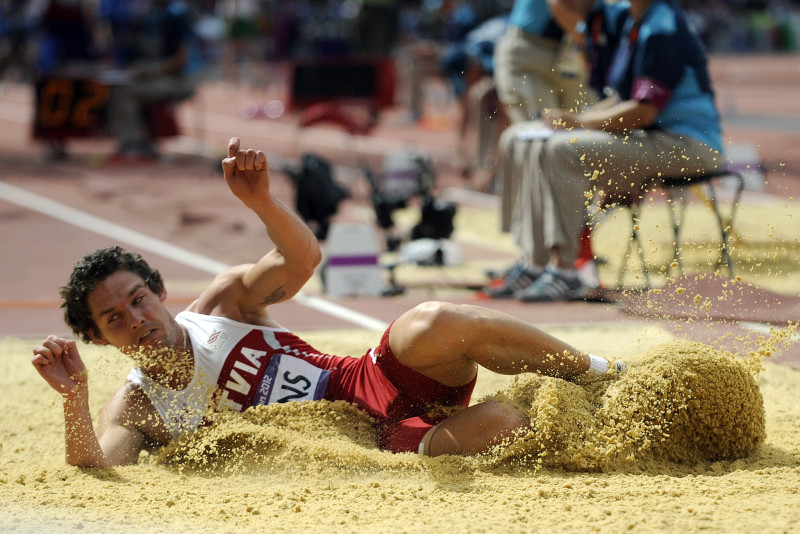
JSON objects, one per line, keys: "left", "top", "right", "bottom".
{"left": 0, "top": 326, "right": 800, "bottom": 533}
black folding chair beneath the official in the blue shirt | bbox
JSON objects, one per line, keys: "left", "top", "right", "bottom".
{"left": 617, "top": 169, "right": 745, "bottom": 289}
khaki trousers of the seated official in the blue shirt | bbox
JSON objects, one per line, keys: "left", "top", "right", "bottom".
{"left": 498, "top": 122, "right": 722, "bottom": 265}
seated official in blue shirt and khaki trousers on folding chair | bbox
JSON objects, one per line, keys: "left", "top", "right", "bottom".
{"left": 488, "top": 0, "right": 723, "bottom": 302}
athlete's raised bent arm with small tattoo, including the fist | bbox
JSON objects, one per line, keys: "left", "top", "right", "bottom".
{"left": 189, "top": 137, "right": 322, "bottom": 324}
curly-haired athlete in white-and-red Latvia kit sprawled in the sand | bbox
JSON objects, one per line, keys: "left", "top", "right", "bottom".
{"left": 32, "top": 138, "right": 613, "bottom": 467}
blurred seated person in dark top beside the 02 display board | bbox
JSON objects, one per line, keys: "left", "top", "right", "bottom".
{"left": 109, "top": 0, "right": 199, "bottom": 158}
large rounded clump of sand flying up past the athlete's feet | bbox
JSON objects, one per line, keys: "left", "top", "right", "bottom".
{"left": 600, "top": 342, "right": 766, "bottom": 462}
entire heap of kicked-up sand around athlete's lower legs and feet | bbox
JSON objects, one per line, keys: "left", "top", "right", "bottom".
{"left": 488, "top": 341, "right": 765, "bottom": 471}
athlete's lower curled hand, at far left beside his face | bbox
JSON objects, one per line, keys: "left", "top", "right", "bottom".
{"left": 31, "top": 336, "right": 88, "bottom": 398}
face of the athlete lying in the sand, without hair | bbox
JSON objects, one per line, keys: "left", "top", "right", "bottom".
{"left": 87, "top": 270, "right": 182, "bottom": 355}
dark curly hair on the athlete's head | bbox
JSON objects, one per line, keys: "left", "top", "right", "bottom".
{"left": 59, "top": 246, "right": 164, "bottom": 343}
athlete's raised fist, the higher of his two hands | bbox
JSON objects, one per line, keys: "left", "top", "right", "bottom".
{"left": 222, "top": 137, "right": 270, "bottom": 211}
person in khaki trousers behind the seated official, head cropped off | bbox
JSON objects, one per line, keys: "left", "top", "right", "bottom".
{"left": 484, "top": 0, "right": 597, "bottom": 298}
